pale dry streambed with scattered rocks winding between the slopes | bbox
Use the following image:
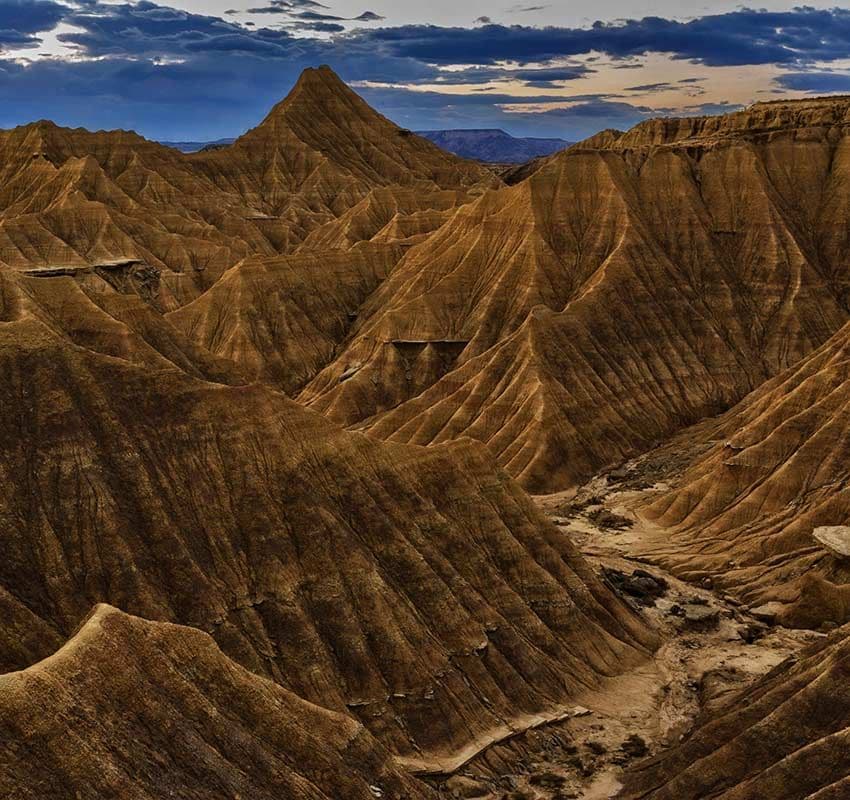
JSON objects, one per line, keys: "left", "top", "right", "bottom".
{"left": 428, "top": 459, "right": 827, "bottom": 800}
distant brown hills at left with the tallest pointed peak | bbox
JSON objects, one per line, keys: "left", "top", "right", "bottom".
{"left": 0, "top": 68, "right": 495, "bottom": 308}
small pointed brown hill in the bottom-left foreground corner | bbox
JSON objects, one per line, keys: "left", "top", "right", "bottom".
{"left": 0, "top": 605, "right": 433, "bottom": 800}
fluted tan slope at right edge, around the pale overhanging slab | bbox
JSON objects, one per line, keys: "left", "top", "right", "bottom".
{"left": 642, "top": 318, "right": 850, "bottom": 627}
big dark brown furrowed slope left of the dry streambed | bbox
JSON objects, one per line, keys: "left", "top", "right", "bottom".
{"left": 0, "top": 315, "right": 653, "bottom": 763}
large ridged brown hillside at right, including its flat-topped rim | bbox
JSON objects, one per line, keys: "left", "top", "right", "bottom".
{"left": 301, "top": 100, "right": 850, "bottom": 491}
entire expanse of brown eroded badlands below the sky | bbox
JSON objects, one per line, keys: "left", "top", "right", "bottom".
{"left": 0, "top": 67, "right": 850, "bottom": 800}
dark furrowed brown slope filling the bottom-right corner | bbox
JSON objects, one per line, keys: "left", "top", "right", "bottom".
{"left": 618, "top": 627, "right": 850, "bottom": 800}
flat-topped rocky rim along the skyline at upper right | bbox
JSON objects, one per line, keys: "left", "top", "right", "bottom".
{"left": 596, "top": 97, "right": 850, "bottom": 150}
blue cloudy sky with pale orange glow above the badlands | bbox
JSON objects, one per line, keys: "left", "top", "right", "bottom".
{"left": 0, "top": 0, "right": 850, "bottom": 141}
